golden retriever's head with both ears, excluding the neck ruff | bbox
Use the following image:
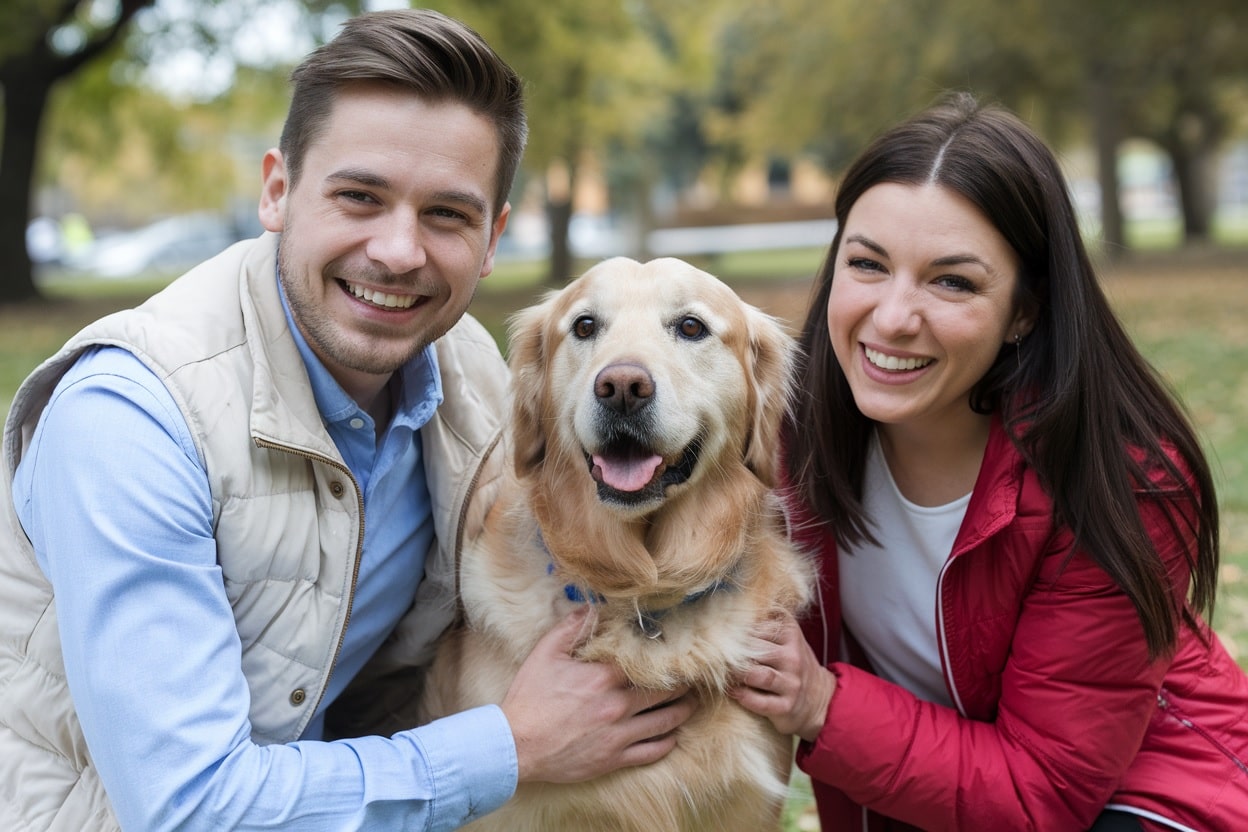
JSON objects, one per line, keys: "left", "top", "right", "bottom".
{"left": 510, "top": 257, "right": 794, "bottom": 515}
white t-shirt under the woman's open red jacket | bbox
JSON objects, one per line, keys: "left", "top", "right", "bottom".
{"left": 837, "top": 434, "right": 971, "bottom": 705}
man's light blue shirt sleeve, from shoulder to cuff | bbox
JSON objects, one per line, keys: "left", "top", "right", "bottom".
{"left": 14, "top": 348, "right": 517, "bottom": 830}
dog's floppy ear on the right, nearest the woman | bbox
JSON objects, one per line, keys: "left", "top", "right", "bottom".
{"left": 745, "top": 307, "right": 797, "bottom": 488}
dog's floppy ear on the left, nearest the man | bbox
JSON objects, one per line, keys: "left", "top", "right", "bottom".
{"left": 508, "top": 297, "right": 550, "bottom": 476}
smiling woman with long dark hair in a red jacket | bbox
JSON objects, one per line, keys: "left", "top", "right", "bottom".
{"left": 735, "top": 95, "right": 1248, "bottom": 832}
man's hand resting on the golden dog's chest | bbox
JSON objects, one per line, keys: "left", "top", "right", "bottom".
{"left": 502, "top": 607, "right": 694, "bottom": 783}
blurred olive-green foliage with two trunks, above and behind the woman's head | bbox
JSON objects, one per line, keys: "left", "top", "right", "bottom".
{"left": 720, "top": 0, "right": 1248, "bottom": 247}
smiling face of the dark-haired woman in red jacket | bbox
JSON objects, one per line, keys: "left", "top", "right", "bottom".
{"left": 827, "top": 183, "right": 1031, "bottom": 437}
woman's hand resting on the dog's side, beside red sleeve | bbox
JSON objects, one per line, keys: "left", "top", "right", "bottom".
{"left": 729, "top": 612, "right": 836, "bottom": 742}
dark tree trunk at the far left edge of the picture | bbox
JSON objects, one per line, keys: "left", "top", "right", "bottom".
{"left": 0, "top": 76, "right": 51, "bottom": 303}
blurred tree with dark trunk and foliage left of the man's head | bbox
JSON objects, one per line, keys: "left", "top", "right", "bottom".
{"left": 0, "top": 0, "right": 362, "bottom": 302}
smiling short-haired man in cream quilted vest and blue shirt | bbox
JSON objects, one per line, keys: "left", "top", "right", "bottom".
{"left": 0, "top": 11, "right": 691, "bottom": 832}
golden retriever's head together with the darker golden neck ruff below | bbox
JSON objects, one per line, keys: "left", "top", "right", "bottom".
{"left": 501, "top": 257, "right": 795, "bottom": 594}
